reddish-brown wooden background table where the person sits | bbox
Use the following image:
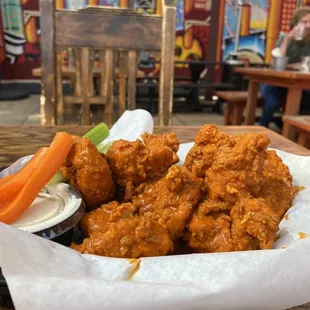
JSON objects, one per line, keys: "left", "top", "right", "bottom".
{"left": 235, "top": 67, "right": 310, "bottom": 139}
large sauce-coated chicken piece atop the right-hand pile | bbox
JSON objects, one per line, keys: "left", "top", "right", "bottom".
{"left": 205, "top": 133, "right": 270, "bottom": 208}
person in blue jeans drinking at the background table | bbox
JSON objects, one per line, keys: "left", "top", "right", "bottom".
{"left": 259, "top": 7, "right": 310, "bottom": 127}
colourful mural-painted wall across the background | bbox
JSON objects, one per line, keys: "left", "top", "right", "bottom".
{"left": 0, "top": 0, "right": 310, "bottom": 79}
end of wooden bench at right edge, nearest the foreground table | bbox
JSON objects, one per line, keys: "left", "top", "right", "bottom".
{"left": 282, "top": 115, "right": 310, "bottom": 149}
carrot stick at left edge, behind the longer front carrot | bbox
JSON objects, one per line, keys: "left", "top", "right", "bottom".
{"left": 0, "top": 147, "right": 48, "bottom": 203}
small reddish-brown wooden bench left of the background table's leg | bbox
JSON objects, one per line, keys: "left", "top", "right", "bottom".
{"left": 216, "top": 91, "right": 263, "bottom": 125}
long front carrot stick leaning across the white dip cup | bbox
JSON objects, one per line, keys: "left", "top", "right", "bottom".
{"left": 0, "top": 132, "right": 73, "bottom": 224}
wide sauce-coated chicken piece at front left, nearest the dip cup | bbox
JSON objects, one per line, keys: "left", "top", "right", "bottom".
{"left": 71, "top": 204, "right": 173, "bottom": 258}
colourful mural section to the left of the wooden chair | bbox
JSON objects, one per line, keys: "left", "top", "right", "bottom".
{"left": 0, "top": 0, "right": 40, "bottom": 79}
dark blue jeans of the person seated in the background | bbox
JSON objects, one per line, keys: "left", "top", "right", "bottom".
{"left": 259, "top": 84, "right": 310, "bottom": 127}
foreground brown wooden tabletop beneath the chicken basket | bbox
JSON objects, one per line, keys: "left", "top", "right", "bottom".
{"left": 0, "top": 126, "right": 310, "bottom": 310}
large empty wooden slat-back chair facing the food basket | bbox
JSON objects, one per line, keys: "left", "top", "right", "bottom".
{"left": 40, "top": 0, "right": 176, "bottom": 125}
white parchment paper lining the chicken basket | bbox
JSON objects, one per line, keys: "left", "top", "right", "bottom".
{"left": 0, "top": 111, "right": 310, "bottom": 310}
